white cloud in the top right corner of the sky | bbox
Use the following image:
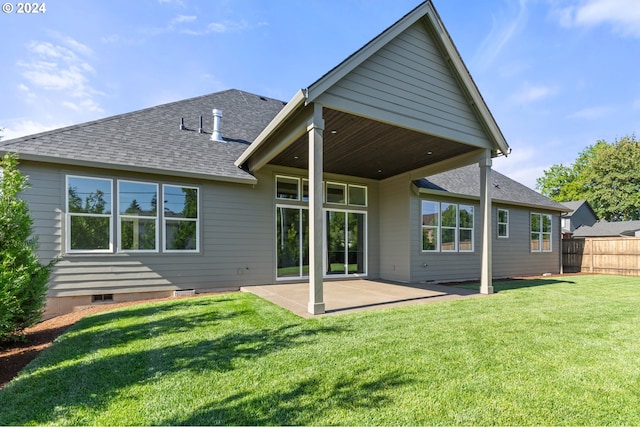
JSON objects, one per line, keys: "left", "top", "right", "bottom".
{"left": 552, "top": 0, "right": 640, "bottom": 38}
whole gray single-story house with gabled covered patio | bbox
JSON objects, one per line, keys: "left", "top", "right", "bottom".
{"left": 0, "top": 1, "right": 567, "bottom": 315}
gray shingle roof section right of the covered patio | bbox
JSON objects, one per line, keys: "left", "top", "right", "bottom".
{"left": 414, "top": 164, "right": 567, "bottom": 212}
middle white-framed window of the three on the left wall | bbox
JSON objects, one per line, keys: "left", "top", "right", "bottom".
{"left": 118, "top": 180, "right": 159, "bottom": 252}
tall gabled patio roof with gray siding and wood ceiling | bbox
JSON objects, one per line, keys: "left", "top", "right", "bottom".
{"left": 236, "top": 0, "right": 510, "bottom": 179}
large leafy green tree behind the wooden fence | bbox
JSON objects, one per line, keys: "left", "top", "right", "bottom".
{"left": 536, "top": 135, "right": 640, "bottom": 221}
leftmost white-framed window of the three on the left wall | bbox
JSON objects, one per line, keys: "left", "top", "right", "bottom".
{"left": 66, "top": 175, "right": 113, "bottom": 253}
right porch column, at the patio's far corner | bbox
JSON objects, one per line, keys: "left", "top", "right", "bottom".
{"left": 479, "top": 151, "right": 493, "bottom": 294}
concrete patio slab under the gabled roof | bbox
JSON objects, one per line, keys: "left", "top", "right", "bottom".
{"left": 240, "top": 279, "right": 488, "bottom": 317}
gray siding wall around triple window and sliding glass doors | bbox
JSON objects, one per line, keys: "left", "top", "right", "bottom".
{"left": 20, "top": 161, "right": 380, "bottom": 316}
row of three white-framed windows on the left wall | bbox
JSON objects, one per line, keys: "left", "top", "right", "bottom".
{"left": 66, "top": 175, "right": 200, "bottom": 253}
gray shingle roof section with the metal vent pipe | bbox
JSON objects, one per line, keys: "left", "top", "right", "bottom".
{"left": 0, "top": 89, "right": 286, "bottom": 182}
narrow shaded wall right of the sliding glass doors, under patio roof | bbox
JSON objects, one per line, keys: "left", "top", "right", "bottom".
{"left": 380, "top": 179, "right": 412, "bottom": 282}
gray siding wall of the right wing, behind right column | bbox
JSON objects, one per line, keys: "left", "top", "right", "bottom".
{"left": 410, "top": 194, "right": 561, "bottom": 283}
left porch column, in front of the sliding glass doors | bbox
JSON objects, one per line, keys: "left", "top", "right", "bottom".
{"left": 307, "top": 104, "right": 324, "bottom": 314}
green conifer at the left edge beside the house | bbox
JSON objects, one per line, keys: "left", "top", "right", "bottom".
{"left": 0, "top": 153, "right": 54, "bottom": 342}
